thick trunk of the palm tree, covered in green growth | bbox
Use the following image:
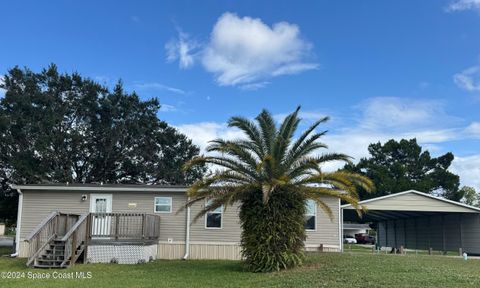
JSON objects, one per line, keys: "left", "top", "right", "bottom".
{"left": 240, "top": 189, "right": 306, "bottom": 272}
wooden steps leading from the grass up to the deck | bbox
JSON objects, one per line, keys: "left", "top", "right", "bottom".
{"left": 33, "top": 239, "right": 85, "bottom": 269}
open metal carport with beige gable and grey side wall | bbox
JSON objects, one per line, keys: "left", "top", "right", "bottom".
{"left": 341, "top": 190, "right": 480, "bottom": 254}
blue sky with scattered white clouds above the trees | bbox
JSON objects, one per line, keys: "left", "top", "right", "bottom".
{"left": 0, "top": 0, "right": 480, "bottom": 190}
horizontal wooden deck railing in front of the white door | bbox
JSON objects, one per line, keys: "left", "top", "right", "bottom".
{"left": 90, "top": 213, "right": 160, "bottom": 240}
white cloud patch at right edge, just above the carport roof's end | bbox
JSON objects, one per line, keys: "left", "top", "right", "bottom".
{"left": 450, "top": 155, "right": 480, "bottom": 192}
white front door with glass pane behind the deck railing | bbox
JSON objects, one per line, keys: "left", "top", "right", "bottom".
{"left": 90, "top": 194, "right": 112, "bottom": 238}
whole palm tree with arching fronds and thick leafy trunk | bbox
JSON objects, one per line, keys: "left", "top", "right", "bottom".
{"left": 185, "top": 107, "right": 373, "bottom": 272}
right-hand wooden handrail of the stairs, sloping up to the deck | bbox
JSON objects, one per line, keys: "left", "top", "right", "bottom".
{"left": 60, "top": 213, "right": 90, "bottom": 267}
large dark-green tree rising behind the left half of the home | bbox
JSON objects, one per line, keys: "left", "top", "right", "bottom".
{"left": 0, "top": 65, "right": 204, "bottom": 218}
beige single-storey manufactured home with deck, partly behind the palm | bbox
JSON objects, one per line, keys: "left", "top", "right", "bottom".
{"left": 14, "top": 184, "right": 342, "bottom": 267}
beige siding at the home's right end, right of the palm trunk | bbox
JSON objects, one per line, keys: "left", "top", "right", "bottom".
{"left": 305, "top": 197, "right": 340, "bottom": 247}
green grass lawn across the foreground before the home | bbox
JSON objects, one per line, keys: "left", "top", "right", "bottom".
{"left": 0, "top": 252, "right": 480, "bottom": 288}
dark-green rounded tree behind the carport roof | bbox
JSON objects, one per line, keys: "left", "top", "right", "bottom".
{"left": 345, "top": 139, "right": 463, "bottom": 201}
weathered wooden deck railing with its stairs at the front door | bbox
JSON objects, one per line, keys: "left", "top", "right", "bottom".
{"left": 27, "top": 212, "right": 160, "bottom": 268}
